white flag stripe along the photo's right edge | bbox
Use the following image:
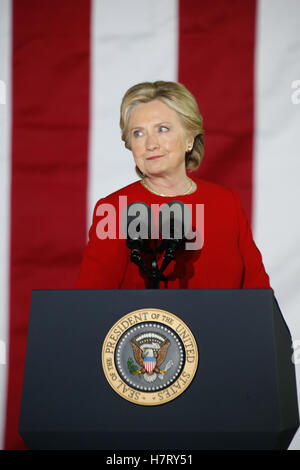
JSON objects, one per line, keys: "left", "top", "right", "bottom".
{"left": 254, "top": 0, "right": 300, "bottom": 449}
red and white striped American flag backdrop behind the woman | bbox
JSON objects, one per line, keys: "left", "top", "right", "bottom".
{"left": 0, "top": 0, "right": 300, "bottom": 449}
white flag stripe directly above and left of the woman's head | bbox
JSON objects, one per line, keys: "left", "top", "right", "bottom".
{"left": 88, "top": 0, "right": 178, "bottom": 225}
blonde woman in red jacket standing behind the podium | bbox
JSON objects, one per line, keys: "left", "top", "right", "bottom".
{"left": 75, "top": 81, "right": 270, "bottom": 289}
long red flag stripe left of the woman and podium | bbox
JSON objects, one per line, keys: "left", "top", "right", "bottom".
{"left": 5, "top": 0, "right": 90, "bottom": 449}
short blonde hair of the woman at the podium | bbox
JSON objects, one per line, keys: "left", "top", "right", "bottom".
{"left": 120, "top": 80, "right": 204, "bottom": 176}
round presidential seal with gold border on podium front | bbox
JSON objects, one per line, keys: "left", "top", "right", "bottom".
{"left": 102, "top": 308, "right": 198, "bottom": 406}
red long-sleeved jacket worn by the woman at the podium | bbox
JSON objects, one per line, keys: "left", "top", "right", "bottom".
{"left": 74, "top": 178, "right": 270, "bottom": 289}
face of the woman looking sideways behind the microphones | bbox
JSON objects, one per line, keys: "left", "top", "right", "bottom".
{"left": 129, "top": 100, "right": 193, "bottom": 176}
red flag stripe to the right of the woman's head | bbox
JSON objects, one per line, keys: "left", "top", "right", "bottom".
{"left": 178, "top": 0, "right": 256, "bottom": 219}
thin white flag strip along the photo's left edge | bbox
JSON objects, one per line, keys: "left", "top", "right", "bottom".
{"left": 0, "top": 0, "right": 12, "bottom": 449}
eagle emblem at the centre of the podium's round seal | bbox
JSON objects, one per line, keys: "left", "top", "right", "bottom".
{"left": 128, "top": 332, "right": 173, "bottom": 382}
